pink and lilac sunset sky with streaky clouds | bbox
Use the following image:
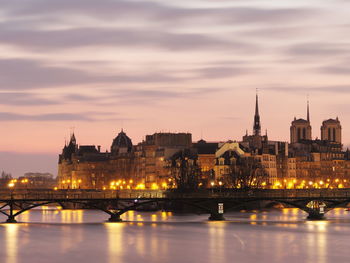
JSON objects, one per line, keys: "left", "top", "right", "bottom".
{"left": 0, "top": 0, "right": 350, "bottom": 176}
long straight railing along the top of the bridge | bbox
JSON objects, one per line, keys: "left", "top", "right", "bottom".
{"left": 0, "top": 189, "right": 350, "bottom": 202}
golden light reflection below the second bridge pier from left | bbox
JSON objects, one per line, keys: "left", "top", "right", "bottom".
{"left": 104, "top": 223, "right": 125, "bottom": 263}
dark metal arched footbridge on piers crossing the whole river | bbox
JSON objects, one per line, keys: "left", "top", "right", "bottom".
{"left": 0, "top": 189, "right": 350, "bottom": 223}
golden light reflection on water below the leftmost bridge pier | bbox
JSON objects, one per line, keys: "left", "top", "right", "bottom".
{"left": 3, "top": 224, "right": 20, "bottom": 263}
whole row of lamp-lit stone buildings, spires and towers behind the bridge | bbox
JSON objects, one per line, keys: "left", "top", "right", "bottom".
{"left": 58, "top": 96, "right": 350, "bottom": 189}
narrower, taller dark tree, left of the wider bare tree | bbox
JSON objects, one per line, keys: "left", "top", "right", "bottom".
{"left": 170, "top": 150, "right": 200, "bottom": 190}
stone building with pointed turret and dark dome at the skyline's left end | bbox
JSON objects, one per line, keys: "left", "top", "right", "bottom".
{"left": 58, "top": 131, "right": 135, "bottom": 189}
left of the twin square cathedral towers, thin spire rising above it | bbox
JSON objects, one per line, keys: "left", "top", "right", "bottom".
{"left": 290, "top": 101, "right": 312, "bottom": 143}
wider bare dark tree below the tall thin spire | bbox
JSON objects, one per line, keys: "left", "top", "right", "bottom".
{"left": 228, "top": 157, "right": 268, "bottom": 189}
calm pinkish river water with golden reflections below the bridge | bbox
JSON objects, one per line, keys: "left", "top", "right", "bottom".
{"left": 0, "top": 207, "right": 350, "bottom": 263}
